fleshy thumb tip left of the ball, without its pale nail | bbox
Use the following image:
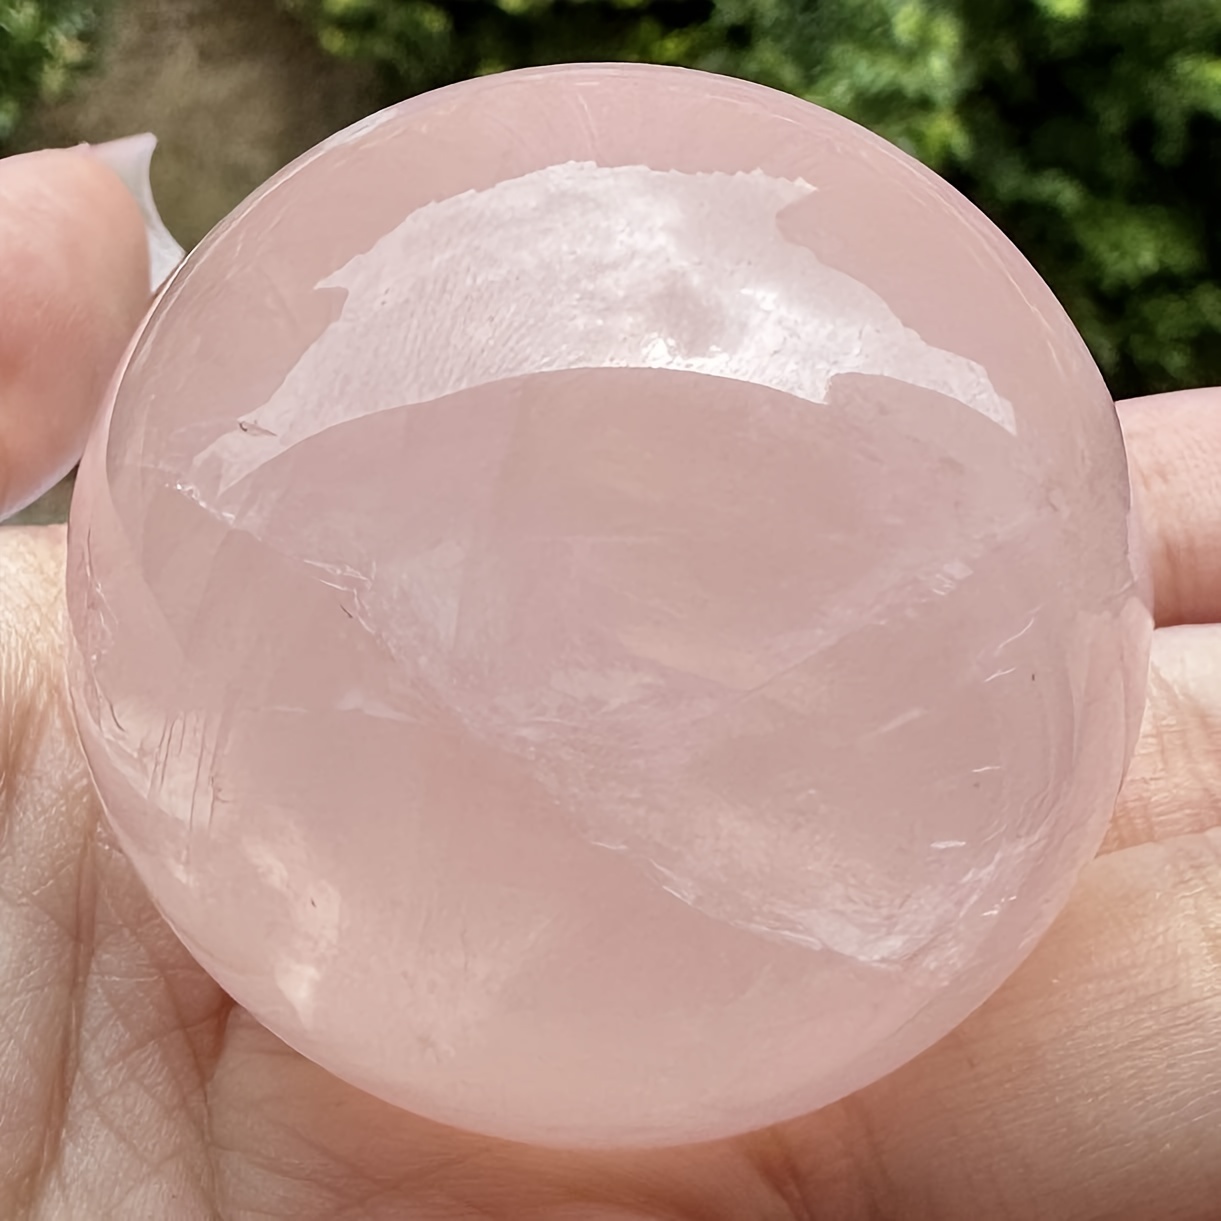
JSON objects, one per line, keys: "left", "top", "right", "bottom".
{"left": 0, "top": 150, "right": 149, "bottom": 516}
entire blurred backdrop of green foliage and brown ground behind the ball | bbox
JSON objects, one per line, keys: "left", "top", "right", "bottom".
{"left": 0, "top": 0, "right": 1221, "bottom": 515}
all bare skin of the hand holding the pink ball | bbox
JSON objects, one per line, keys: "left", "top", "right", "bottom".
{"left": 0, "top": 153, "right": 1221, "bottom": 1221}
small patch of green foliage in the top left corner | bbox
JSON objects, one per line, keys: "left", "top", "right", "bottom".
{"left": 0, "top": 0, "right": 103, "bottom": 148}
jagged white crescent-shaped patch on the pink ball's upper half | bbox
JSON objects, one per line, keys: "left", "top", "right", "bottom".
{"left": 197, "top": 162, "right": 1015, "bottom": 496}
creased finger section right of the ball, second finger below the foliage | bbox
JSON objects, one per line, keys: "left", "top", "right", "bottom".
{"left": 1100, "top": 625, "right": 1221, "bottom": 853}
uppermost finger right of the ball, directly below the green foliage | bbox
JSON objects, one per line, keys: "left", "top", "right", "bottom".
{"left": 1118, "top": 388, "right": 1221, "bottom": 625}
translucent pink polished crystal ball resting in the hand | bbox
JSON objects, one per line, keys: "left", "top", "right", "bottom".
{"left": 68, "top": 66, "right": 1150, "bottom": 1145}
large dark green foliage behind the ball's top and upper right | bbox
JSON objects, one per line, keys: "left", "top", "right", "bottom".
{"left": 290, "top": 0, "right": 1221, "bottom": 394}
